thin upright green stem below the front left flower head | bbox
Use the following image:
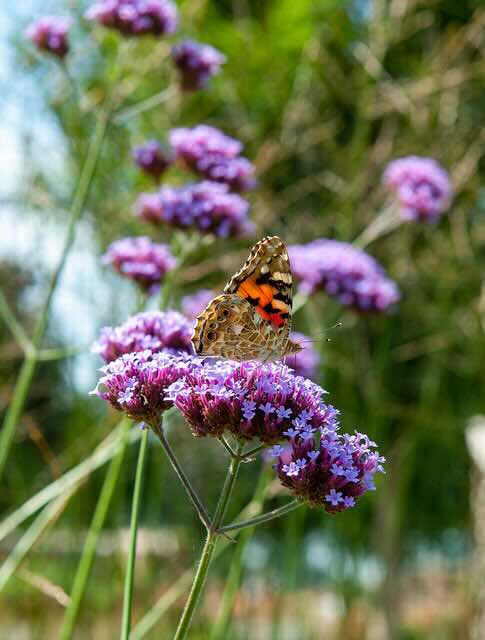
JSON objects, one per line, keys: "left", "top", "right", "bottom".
{"left": 120, "top": 429, "right": 149, "bottom": 640}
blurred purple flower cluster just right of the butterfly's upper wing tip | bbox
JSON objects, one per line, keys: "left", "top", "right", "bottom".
{"left": 289, "top": 238, "right": 399, "bottom": 312}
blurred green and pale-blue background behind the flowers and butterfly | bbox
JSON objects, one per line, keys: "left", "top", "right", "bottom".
{"left": 0, "top": 0, "right": 485, "bottom": 640}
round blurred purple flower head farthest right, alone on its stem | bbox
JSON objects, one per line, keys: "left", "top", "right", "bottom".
{"left": 383, "top": 156, "right": 452, "bottom": 222}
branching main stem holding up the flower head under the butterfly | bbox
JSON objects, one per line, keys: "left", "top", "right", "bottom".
{"left": 173, "top": 444, "right": 243, "bottom": 640}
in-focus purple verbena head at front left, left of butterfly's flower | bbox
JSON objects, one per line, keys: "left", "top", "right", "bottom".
{"left": 91, "top": 349, "right": 200, "bottom": 425}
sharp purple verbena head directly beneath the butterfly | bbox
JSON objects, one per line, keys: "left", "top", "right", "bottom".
{"left": 167, "top": 361, "right": 338, "bottom": 444}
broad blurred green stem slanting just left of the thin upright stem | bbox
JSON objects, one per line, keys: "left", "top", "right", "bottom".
{"left": 59, "top": 420, "right": 131, "bottom": 640}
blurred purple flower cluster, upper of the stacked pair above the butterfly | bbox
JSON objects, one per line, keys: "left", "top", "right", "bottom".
{"left": 170, "top": 124, "right": 256, "bottom": 191}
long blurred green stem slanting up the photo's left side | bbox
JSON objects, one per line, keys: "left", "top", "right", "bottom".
{"left": 0, "top": 105, "right": 110, "bottom": 478}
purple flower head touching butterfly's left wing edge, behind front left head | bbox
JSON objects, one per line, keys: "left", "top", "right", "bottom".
{"left": 92, "top": 311, "right": 193, "bottom": 362}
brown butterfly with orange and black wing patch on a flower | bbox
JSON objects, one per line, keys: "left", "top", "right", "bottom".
{"left": 192, "top": 236, "right": 301, "bottom": 362}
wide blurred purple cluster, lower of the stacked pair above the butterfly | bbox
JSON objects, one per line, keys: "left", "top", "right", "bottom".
{"left": 135, "top": 181, "right": 253, "bottom": 238}
